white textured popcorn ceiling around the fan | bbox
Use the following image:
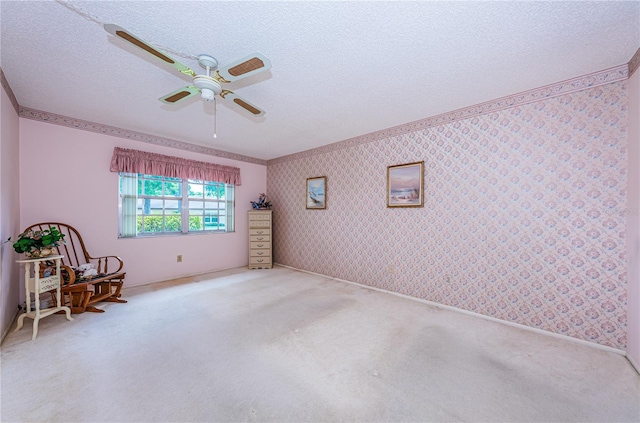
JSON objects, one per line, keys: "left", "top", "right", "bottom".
{"left": 0, "top": 0, "right": 640, "bottom": 159}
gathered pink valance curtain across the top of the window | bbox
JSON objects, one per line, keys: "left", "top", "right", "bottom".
{"left": 110, "top": 147, "right": 241, "bottom": 185}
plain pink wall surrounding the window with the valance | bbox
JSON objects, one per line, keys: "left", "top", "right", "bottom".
{"left": 20, "top": 119, "right": 266, "bottom": 286}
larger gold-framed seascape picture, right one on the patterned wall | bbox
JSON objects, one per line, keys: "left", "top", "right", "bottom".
{"left": 387, "top": 162, "right": 424, "bottom": 207}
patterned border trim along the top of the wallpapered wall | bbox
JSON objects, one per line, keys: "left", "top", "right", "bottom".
{"left": 267, "top": 63, "right": 638, "bottom": 166}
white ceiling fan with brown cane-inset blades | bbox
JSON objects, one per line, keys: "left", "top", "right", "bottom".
{"left": 104, "top": 24, "right": 271, "bottom": 116}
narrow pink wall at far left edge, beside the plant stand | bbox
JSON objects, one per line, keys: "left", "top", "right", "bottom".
{"left": 0, "top": 84, "right": 21, "bottom": 340}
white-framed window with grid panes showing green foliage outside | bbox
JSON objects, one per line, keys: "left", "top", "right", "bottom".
{"left": 119, "top": 172, "right": 234, "bottom": 238}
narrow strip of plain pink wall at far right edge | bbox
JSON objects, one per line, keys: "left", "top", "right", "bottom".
{"left": 627, "top": 65, "right": 640, "bottom": 371}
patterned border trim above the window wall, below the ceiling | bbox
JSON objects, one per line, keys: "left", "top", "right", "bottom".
{"left": 19, "top": 107, "right": 267, "bottom": 166}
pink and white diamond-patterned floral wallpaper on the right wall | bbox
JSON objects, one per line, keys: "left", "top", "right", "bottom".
{"left": 267, "top": 81, "right": 627, "bottom": 349}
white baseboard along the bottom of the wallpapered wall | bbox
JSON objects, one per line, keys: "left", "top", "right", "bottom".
{"left": 275, "top": 263, "right": 624, "bottom": 358}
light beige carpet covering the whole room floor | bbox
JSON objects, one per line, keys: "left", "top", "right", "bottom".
{"left": 1, "top": 267, "right": 640, "bottom": 422}
